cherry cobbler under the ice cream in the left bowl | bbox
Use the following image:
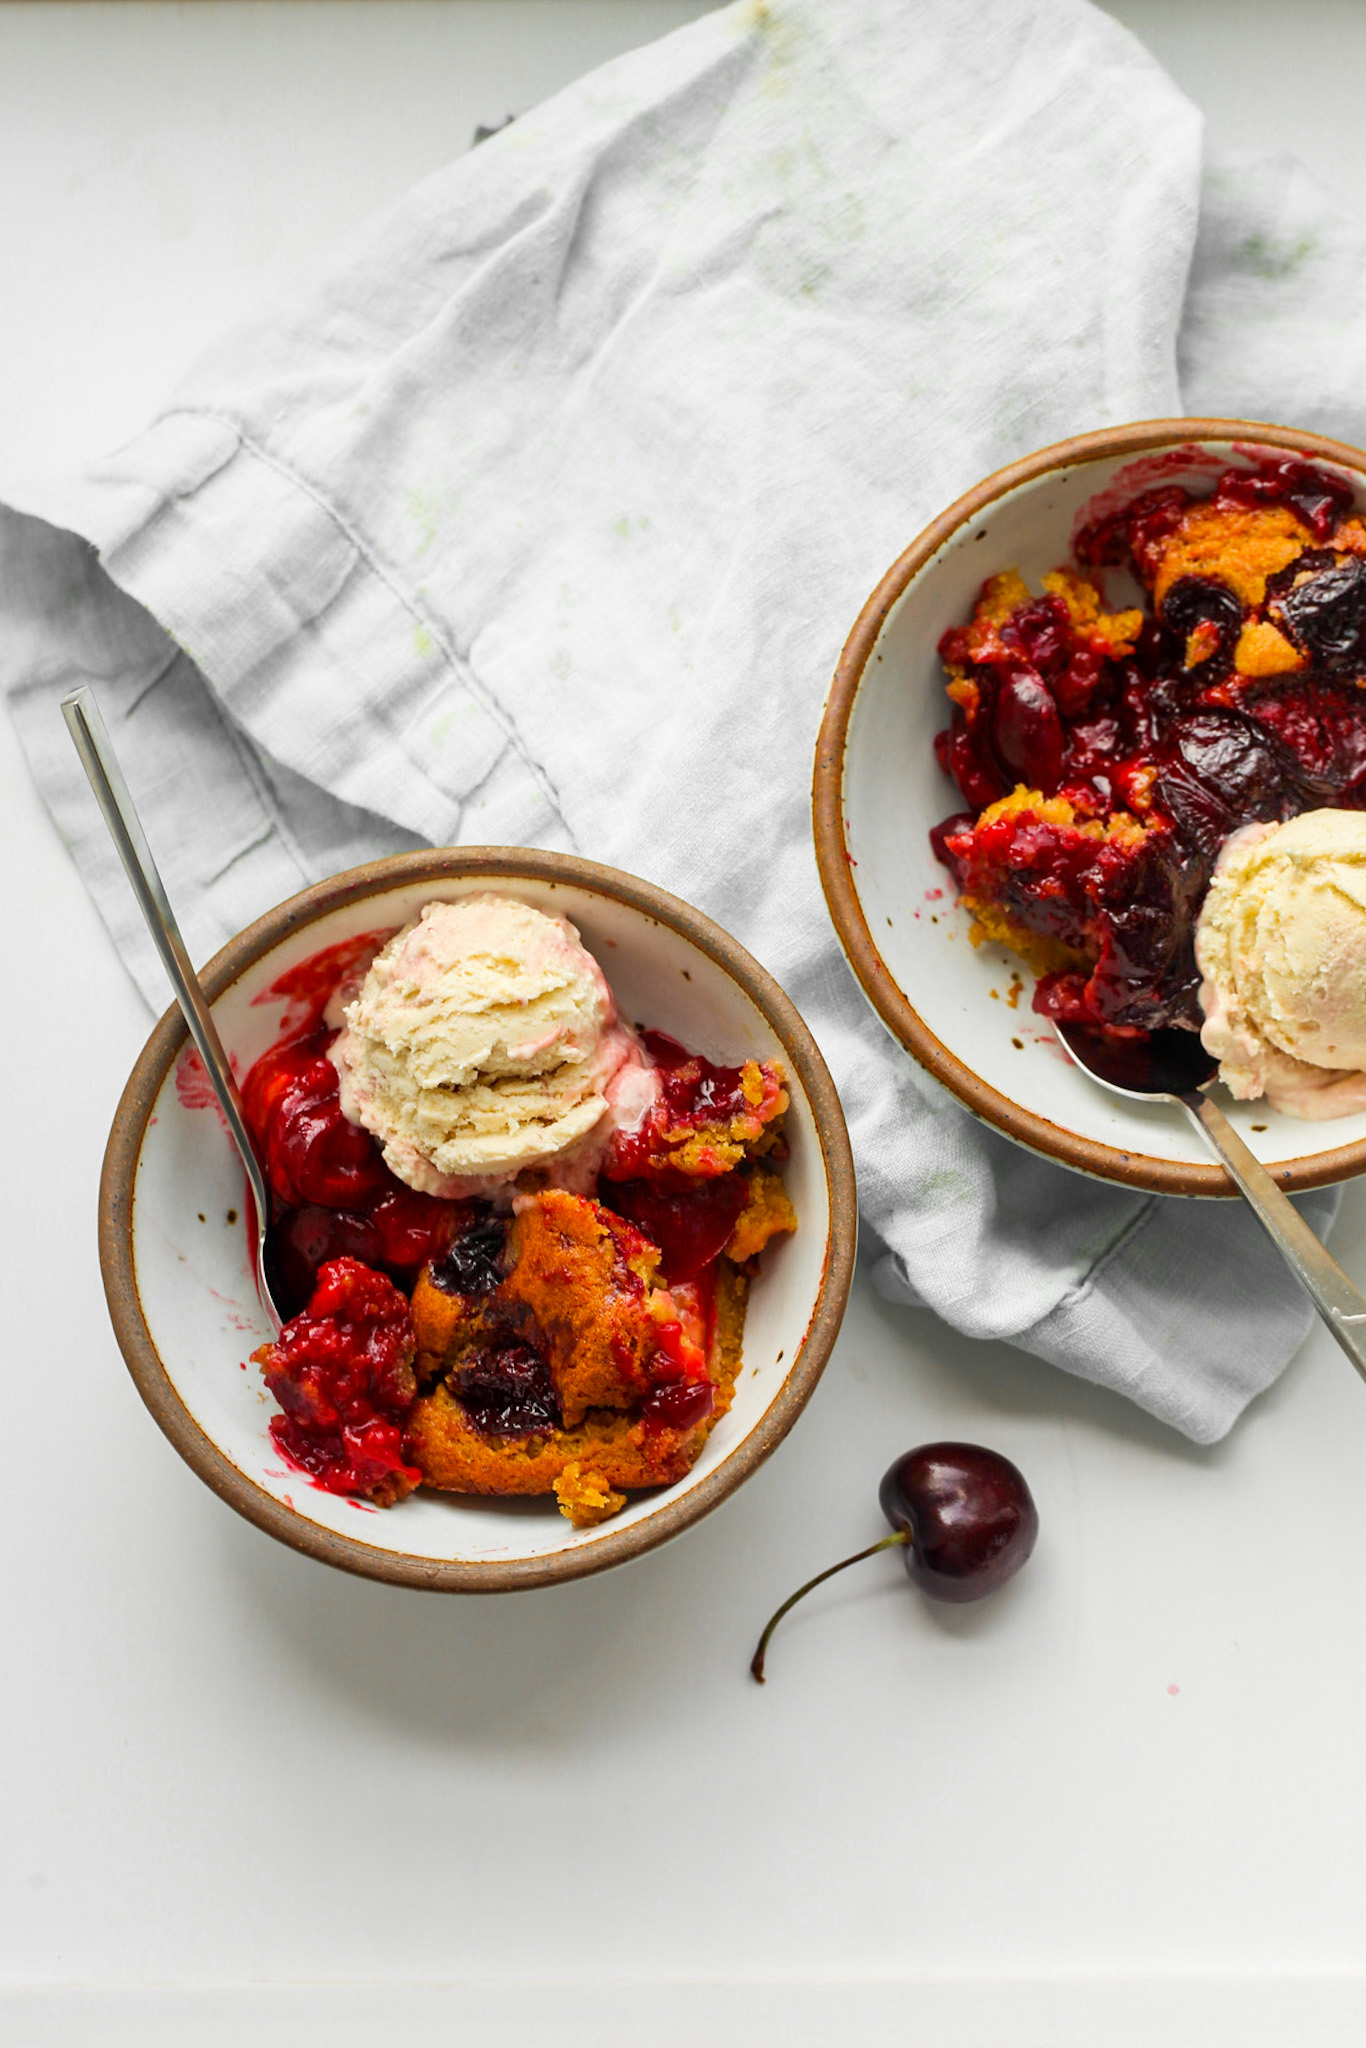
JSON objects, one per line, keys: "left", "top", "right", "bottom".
{"left": 232, "top": 934, "right": 797, "bottom": 1526}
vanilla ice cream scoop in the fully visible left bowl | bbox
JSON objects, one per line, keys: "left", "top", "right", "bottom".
{"left": 330, "top": 895, "right": 655, "bottom": 1198}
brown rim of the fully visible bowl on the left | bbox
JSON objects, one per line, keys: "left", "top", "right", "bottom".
{"left": 100, "top": 846, "right": 858, "bottom": 1593}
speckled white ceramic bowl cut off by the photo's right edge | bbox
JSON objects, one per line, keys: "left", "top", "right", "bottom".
{"left": 813, "top": 420, "right": 1366, "bottom": 1196}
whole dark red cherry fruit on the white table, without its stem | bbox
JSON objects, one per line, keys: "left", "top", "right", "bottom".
{"left": 879, "top": 1444, "right": 1038, "bottom": 1602}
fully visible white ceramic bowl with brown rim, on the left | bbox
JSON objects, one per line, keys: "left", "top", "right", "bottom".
{"left": 100, "top": 848, "right": 856, "bottom": 1591}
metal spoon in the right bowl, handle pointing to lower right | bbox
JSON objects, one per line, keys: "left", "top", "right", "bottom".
{"left": 1055, "top": 1024, "right": 1366, "bottom": 1380}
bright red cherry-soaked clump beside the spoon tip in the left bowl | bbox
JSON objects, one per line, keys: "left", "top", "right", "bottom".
{"left": 256, "top": 1257, "right": 422, "bottom": 1501}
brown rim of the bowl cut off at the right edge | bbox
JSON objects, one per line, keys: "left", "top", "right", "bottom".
{"left": 811, "top": 420, "right": 1366, "bottom": 1198}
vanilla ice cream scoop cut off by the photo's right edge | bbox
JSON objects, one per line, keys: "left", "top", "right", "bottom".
{"left": 1196, "top": 811, "right": 1366, "bottom": 1118}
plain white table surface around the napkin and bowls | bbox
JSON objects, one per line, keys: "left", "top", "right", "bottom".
{"left": 0, "top": 0, "right": 1366, "bottom": 2048}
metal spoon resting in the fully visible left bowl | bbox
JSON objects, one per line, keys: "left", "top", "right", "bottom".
{"left": 61, "top": 688, "right": 283, "bottom": 1329}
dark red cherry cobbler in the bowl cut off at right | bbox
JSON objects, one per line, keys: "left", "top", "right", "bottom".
{"left": 930, "top": 461, "right": 1366, "bottom": 1034}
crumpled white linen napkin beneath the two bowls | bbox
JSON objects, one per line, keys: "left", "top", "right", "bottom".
{"left": 0, "top": 0, "right": 1366, "bottom": 1442}
